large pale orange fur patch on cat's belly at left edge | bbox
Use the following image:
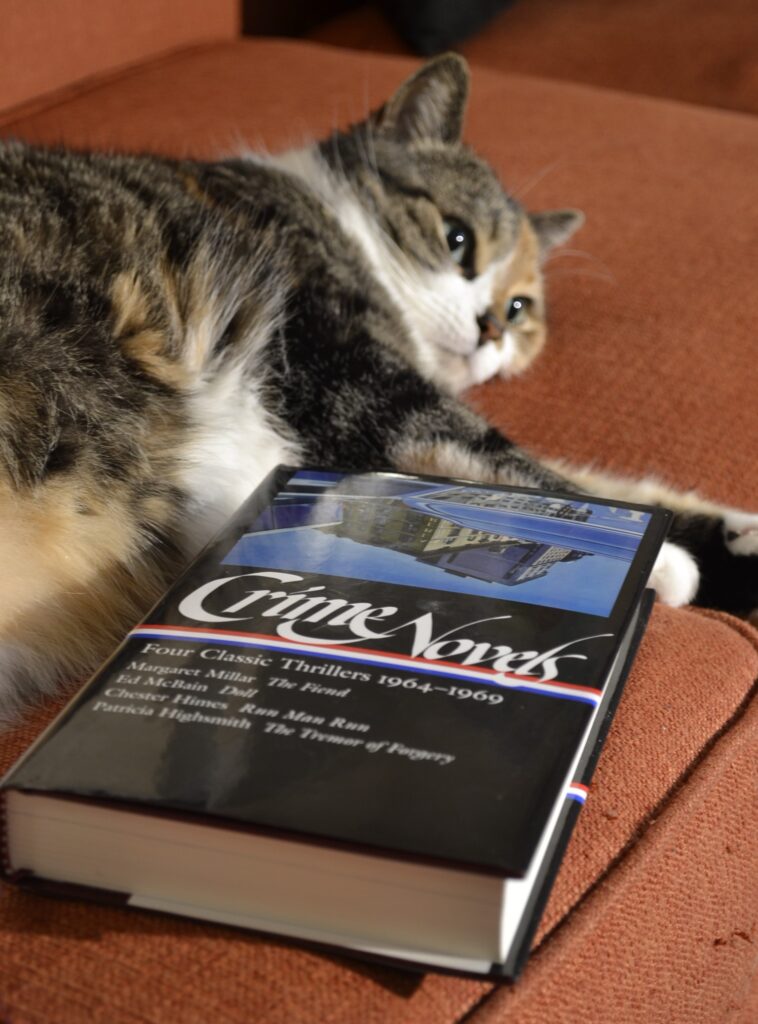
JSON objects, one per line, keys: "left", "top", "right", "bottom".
{"left": 0, "top": 475, "right": 182, "bottom": 704}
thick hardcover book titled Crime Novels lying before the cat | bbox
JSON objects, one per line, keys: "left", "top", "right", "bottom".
{"left": 0, "top": 467, "right": 670, "bottom": 978}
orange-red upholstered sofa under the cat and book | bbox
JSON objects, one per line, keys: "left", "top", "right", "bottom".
{"left": 0, "top": 0, "right": 758, "bottom": 1024}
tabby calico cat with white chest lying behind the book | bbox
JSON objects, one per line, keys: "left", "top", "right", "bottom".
{"left": 0, "top": 55, "right": 758, "bottom": 721}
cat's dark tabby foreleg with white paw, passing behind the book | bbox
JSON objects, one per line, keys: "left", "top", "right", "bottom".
{"left": 271, "top": 331, "right": 698, "bottom": 604}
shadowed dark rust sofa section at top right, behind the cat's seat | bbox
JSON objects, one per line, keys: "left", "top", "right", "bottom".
{"left": 309, "top": 0, "right": 758, "bottom": 114}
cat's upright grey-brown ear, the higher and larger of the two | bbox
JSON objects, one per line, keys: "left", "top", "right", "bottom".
{"left": 374, "top": 53, "right": 468, "bottom": 143}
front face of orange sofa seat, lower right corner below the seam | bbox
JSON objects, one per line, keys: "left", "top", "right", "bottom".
{"left": 473, "top": 671, "right": 758, "bottom": 1024}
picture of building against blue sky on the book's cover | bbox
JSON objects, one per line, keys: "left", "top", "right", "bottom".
{"left": 224, "top": 470, "right": 650, "bottom": 615}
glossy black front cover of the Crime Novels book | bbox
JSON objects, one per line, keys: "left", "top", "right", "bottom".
{"left": 3, "top": 468, "right": 668, "bottom": 966}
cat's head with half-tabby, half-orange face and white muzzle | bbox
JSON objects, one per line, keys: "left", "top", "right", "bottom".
{"left": 321, "top": 54, "right": 583, "bottom": 390}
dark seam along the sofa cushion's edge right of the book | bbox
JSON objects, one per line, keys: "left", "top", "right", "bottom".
{"left": 455, "top": 608, "right": 758, "bottom": 1024}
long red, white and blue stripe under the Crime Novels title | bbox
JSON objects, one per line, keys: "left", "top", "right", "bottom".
{"left": 129, "top": 624, "right": 602, "bottom": 707}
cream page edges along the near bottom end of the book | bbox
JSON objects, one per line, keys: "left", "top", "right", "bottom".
{"left": 7, "top": 791, "right": 505, "bottom": 959}
